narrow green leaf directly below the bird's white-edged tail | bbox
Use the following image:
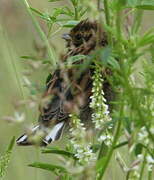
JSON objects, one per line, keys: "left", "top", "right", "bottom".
{"left": 42, "top": 148, "right": 76, "bottom": 159}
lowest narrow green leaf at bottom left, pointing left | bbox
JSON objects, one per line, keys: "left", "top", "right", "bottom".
{"left": 28, "top": 162, "right": 67, "bottom": 175}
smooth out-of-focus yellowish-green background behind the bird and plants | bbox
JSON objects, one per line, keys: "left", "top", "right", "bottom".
{"left": 0, "top": 0, "right": 154, "bottom": 180}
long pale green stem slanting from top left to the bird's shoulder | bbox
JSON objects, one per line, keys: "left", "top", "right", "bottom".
{"left": 23, "top": 0, "right": 56, "bottom": 68}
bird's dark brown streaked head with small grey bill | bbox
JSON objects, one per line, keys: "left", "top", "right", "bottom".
{"left": 63, "top": 19, "right": 107, "bottom": 55}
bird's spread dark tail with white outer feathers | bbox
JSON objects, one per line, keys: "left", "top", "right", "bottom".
{"left": 16, "top": 121, "right": 65, "bottom": 146}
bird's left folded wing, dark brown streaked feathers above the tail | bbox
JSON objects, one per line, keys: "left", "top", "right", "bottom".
{"left": 39, "top": 70, "right": 71, "bottom": 127}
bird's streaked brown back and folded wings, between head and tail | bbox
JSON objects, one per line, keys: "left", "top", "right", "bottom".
{"left": 40, "top": 66, "right": 92, "bottom": 126}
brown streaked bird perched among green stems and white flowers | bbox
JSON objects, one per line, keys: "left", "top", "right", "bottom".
{"left": 16, "top": 19, "right": 112, "bottom": 146}
